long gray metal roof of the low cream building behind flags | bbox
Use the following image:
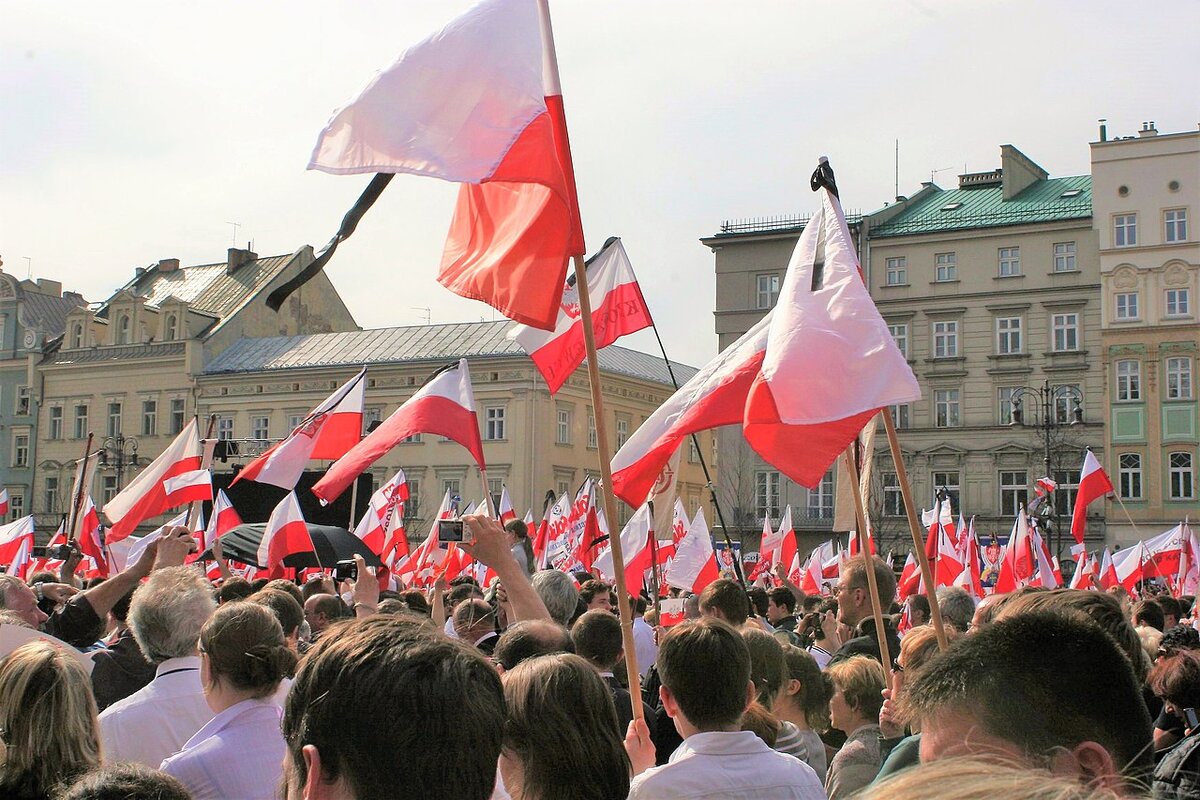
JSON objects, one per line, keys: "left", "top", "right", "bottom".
{"left": 204, "top": 320, "right": 696, "bottom": 386}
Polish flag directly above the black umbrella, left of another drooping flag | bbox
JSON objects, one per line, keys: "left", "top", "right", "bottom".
{"left": 229, "top": 367, "right": 367, "bottom": 489}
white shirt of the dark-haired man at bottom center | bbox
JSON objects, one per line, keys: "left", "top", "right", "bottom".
{"left": 629, "top": 730, "right": 826, "bottom": 800}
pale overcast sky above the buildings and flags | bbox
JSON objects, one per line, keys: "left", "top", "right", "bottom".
{"left": 0, "top": 0, "right": 1200, "bottom": 366}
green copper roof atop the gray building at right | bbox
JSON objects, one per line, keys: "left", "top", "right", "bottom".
{"left": 870, "top": 175, "right": 1092, "bottom": 239}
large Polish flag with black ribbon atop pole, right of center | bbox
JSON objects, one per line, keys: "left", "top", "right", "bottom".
{"left": 612, "top": 184, "right": 920, "bottom": 505}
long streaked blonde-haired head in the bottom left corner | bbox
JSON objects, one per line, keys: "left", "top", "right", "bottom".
{"left": 0, "top": 642, "right": 101, "bottom": 796}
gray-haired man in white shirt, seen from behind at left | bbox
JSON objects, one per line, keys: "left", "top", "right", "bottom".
{"left": 100, "top": 566, "right": 216, "bottom": 769}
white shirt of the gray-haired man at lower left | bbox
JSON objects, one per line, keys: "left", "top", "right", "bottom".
{"left": 100, "top": 656, "right": 212, "bottom": 769}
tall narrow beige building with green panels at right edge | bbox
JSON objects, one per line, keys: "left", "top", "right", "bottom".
{"left": 1092, "top": 122, "right": 1200, "bottom": 543}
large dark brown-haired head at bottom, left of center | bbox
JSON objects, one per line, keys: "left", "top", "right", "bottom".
{"left": 282, "top": 615, "right": 505, "bottom": 800}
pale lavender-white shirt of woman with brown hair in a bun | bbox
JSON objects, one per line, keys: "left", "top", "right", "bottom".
{"left": 160, "top": 698, "right": 286, "bottom": 800}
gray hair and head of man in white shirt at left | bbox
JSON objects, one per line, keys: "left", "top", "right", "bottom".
{"left": 128, "top": 566, "right": 217, "bottom": 663}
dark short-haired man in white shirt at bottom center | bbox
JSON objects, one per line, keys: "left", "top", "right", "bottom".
{"left": 629, "top": 618, "right": 826, "bottom": 800}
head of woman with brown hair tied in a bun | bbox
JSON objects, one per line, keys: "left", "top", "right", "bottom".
{"left": 200, "top": 590, "right": 296, "bottom": 698}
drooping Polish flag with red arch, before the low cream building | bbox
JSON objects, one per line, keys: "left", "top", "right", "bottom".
{"left": 312, "top": 359, "right": 486, "bottom": 504}
